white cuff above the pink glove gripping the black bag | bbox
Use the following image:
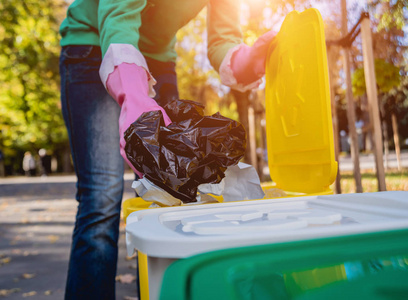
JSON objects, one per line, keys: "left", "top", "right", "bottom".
{"left": 99, "top": 44, "right": 157, "bottom": 98}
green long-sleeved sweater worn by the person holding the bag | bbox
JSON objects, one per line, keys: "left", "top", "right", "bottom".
{"left": 60, "top": 0, "right": 242, "bottom": 71}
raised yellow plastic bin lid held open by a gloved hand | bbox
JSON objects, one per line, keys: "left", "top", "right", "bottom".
{"left": 265, "top": 8, "right": 337, "bottom": 193}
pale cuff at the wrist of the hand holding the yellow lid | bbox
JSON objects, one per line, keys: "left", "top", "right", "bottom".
{"left": 219, "top": 44, "right": 262, "bottom": 92}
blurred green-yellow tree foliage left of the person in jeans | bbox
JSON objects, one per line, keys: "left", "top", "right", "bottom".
{"left": 0, "top": 0, "right": 67, "bottom": 172}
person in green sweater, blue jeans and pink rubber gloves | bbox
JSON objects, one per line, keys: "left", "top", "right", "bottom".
{"left": 60, "top": 0, "right": 275, "bottom": 299}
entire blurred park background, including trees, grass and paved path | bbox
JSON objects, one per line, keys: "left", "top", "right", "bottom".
{"left": 0, "top": 0, "right": 408, "bottom": 300}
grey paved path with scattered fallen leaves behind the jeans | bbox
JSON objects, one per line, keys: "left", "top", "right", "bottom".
{"left": 0, "top": 174, "right": 136, "bottom": 300}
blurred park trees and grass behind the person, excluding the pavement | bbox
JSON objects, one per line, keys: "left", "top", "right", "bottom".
{"left": 0, "top": 0, "right": 408, "bottom": 192}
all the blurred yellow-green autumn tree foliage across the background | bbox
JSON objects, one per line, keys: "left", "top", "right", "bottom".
{"left": 0, "top": 0, "right": 408, "bottom": 173}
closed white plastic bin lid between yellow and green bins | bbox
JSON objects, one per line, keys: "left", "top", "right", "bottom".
{"left": 126, "top": 191, "right": 408, "bottom": 258}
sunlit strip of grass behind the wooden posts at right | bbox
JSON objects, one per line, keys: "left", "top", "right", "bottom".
{"left": 332, "top": 168, "right": 408, "bottom": 194}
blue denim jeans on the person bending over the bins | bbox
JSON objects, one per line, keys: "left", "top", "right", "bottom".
{"left": 60, "top": 45, "right": 178, "bottom": 300}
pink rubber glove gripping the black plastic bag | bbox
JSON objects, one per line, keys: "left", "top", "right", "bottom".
{"left": 106, "top": 63, "right": 171, "bottom": 177}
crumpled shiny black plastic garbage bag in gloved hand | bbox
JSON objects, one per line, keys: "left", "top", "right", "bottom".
{"left": 125, "top": 100, "right": 246, "bottom": 203}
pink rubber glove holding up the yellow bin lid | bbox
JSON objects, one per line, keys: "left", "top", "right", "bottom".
{"left": 231, "top": 31, "right": 276, "bottom": 86}
